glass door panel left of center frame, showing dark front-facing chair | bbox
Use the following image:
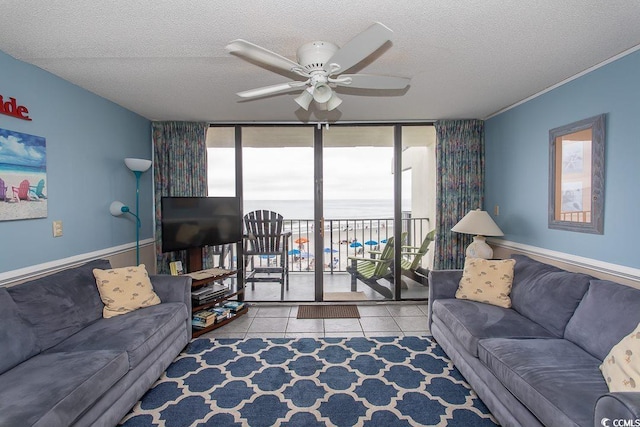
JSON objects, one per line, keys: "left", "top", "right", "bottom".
{"left": 242, "top": 126, "right": 316, "bottom": 301}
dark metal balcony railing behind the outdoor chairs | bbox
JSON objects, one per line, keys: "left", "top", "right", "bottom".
{"left": 245, "top": 214, "right": 430, "bottom": 273}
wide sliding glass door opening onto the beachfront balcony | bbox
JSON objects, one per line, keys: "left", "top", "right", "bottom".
{"left": 207, "top": 125, "right": 435, "bottom": 301}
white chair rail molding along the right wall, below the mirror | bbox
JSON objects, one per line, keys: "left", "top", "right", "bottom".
{"left": 490, "top": 239, "right": 640, "bottom": 282}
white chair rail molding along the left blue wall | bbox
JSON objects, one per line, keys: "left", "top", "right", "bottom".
{"left": 0, "top": 239, "right": 155, "bottom": 286}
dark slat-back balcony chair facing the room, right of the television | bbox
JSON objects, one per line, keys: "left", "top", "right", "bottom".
{"left": 244, "top": 210, "right": 291, "bottom": 300}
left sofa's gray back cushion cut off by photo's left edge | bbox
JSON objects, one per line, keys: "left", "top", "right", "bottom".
{"left": 0, "top": 288, "right": 40, "bottom": 374}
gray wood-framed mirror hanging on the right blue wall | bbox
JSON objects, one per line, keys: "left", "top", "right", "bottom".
{"left": 549, "top": 114, "right": 605, "bottom": 234}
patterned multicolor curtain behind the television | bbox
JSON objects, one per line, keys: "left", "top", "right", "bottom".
{"left": 153, "top": 122, "right": 212, "bottom": 274}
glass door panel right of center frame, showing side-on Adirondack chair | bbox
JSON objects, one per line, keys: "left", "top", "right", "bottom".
{"left": 322, "top": 126, "right": 394, "bottom": 301}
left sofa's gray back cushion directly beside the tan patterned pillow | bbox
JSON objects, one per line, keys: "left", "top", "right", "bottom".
{"left": 7, "top": 260, "right": 109, "bottom": 350}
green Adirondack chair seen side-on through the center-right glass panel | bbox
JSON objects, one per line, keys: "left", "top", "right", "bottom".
{"left": 347, "top": 237, "right": 393, "bottom": 299}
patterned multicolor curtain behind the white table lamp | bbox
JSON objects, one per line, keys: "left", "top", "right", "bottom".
{"left": 434, "top": 120, "right": 484, "bottom": 270}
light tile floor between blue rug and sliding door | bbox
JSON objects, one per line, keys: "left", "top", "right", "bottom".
{"left": 201, "top": 302, "right": 429, "bottom": 338}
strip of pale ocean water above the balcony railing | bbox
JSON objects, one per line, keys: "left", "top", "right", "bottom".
{"left": 244, "top": 199, "right": 402, "bottom": 219}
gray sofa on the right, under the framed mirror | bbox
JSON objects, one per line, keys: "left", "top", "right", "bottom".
{"left": 429, "top": 255, "right": 640, "bottom": 427}
